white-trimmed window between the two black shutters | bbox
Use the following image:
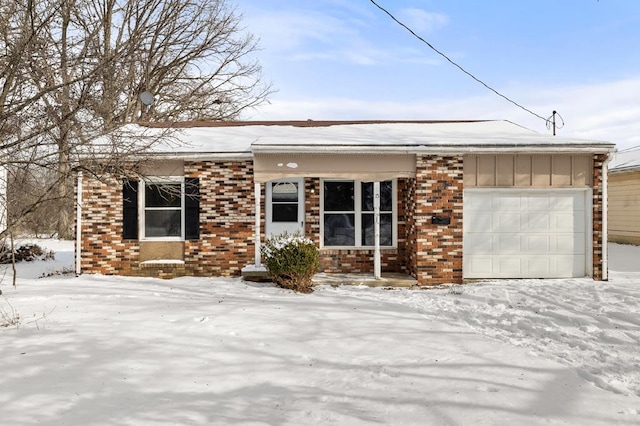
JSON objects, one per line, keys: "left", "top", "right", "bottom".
{"left": 141, "top": 178, "right": 185, "bottom": 240}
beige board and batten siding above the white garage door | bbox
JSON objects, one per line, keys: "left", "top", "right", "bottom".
{"left": 464, "top": 154, "right": 593, "bottom": 188}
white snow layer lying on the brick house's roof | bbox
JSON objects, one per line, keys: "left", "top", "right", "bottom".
{"left": 120, "top": 120, "right": 614, "bottom": 155}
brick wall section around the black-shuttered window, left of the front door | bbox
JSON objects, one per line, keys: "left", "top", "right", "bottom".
{"left": 81, "top": 161, "right": 255, "bottom": 278}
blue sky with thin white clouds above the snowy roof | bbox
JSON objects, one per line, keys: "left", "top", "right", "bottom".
{"left": 235, "top": 0, "right": 640, "bottom": 149}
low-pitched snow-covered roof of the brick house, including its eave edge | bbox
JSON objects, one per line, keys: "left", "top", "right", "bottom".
{"left": 124, "top": 120, "right": 615, "bottom": 156}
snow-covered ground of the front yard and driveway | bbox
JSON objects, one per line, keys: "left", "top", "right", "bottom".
{"left": 0, "top": 242, "right": 640, "bottom": 425}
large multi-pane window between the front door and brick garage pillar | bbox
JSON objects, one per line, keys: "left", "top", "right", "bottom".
{"left": 322, "top": 180, "right": 396, "bottom": 247}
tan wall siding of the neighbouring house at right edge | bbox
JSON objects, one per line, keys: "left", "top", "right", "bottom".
{"left": 608, "top": 170, "right": 640, "bottom": 245}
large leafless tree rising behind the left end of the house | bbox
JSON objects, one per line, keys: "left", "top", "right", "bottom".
{"left": 0, "top": 0, "right": 270, "bottom": 237}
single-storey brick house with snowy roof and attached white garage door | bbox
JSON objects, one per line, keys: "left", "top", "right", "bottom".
{"left": 76, "top": 121, "right": 614, "bottom": 285}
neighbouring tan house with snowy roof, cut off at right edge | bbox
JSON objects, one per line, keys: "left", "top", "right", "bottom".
{"left": 607, "top": 149, "right": 640, "bottom": 245}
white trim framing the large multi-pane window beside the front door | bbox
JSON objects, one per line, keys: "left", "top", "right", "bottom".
{"left": 320, "top": 178, "right": 398, "bottom": 250}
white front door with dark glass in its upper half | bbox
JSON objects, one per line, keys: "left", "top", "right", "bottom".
{"left": 265, "top": 178, "right": 304, "bottom": 236}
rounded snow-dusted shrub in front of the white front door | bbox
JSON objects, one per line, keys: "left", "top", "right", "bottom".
{"left": 261, "top": 232, "right": 319, "bottom": 293}
